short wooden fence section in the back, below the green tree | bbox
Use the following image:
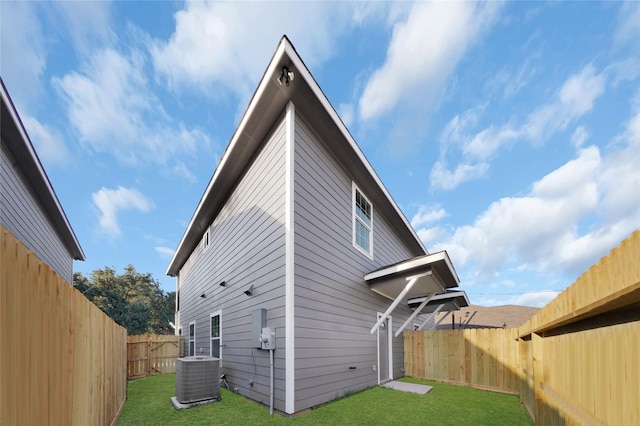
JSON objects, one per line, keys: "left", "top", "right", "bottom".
{"left": 127, "top": 334, "right": 180, "bottom": 379}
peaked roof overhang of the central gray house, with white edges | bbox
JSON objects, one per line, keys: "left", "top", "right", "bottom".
{"left": 167, "top": 36, "right": 427, "bottom": 276}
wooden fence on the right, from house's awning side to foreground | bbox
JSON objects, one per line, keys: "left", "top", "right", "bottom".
{"left": 404, "top": 231, "right": 640, "bottom": 425}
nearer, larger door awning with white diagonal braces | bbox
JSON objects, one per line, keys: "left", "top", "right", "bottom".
{"left": 364, "top": 251, "right": 460, "bottom": 336}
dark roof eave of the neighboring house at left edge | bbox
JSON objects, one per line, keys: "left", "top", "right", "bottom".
{"left": 0, "top": 78, "right": 85, "bottom": 260}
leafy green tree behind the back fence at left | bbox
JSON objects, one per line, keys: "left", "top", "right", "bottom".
{"left": 73, "top": 265, "right": 175, "bottom": 335}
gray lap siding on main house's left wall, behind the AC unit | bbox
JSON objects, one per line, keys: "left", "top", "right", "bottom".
{"left": 179, "top": 116, "right": 286, "bottom": 411}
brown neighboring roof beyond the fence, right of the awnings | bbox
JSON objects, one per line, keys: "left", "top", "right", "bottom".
{"left": 436, "top": 305, "right": 539, "bottom": 329}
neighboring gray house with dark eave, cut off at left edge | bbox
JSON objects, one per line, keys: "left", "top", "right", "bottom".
{"left": 0, "top": 79, "right": 85, "bottom": 283}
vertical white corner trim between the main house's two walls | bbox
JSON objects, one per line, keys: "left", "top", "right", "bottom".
{"left": 285, "top": 102, "right": 296, "bottom": 414}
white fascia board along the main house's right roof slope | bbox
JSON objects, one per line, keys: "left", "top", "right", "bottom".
{"left": 281, "top": 40, "right": 429, "bottom": 254}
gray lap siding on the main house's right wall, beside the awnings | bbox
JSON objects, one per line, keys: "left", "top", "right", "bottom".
{"left": 295, "top": 115, "right": 412, "bottom": 411}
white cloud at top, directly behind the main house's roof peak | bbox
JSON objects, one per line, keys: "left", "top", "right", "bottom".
{"left": 150, "top": 2, "right": 362, "bottom": 99}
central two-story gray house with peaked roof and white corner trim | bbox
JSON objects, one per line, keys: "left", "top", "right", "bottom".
{"left": 167, "top": 37, "right": 459, "bottom": 414}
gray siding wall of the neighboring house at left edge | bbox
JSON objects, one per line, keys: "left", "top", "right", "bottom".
{"left": 0, "top": 141, "right": 73, "bottom": 283}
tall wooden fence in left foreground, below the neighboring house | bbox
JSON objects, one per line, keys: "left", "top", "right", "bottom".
{"left": 0, "top": 227, "right": 127, "bottom": 425}
